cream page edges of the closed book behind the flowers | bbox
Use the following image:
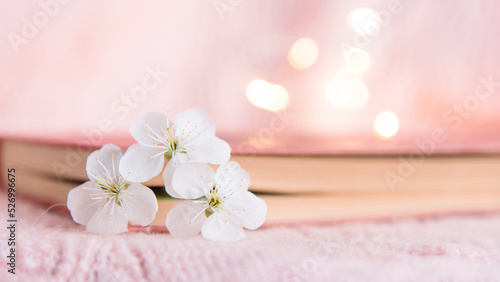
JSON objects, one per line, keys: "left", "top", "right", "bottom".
{"left": 0, "top": 138, "right": 500, "bottom": 229}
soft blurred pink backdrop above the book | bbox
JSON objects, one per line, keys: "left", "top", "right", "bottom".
{"left": 0, "top": 0, "right": 500, "bottom": 151}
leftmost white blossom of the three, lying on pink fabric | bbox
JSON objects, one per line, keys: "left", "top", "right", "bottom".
{"left": 67, "top": 144, "right": 158, "bottom": 234}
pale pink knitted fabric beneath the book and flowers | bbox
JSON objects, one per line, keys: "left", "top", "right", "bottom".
{"left": 0, "top": 193, "right": 500, "bottom": 281}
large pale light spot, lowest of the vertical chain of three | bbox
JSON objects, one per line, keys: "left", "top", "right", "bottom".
{"left": 326, "top": 77, "right": 370, "bottom": 109}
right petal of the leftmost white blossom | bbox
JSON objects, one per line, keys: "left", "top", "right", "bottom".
{"left": 122, "top": 183, "right": 158, "bottom": 226}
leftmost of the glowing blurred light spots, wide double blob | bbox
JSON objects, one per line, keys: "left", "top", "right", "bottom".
{"left": 247, "top": 79, "right": 289, "bottom": 111}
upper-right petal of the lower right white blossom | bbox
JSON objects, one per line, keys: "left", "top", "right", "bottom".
{"left": 215, "top": 161, "right": 250, "bottom": 195}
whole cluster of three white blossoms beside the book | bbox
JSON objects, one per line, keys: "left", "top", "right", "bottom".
{"left": 67, "top": 108, "right": 267, "bottom": 241}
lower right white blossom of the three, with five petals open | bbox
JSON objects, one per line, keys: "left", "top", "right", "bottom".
{"left": 166, "top": 162, "right": 267, "bottom": 241}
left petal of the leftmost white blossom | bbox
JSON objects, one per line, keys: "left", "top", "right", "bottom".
{"left": 66, "top": 181, "right": 107, "bottom": 225}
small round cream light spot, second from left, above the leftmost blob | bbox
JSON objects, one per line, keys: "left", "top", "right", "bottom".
{"left": 288, "top": 37, "right": 319, "bottom": 70}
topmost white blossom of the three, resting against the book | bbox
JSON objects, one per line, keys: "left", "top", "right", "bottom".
{"left": 120, "top": 108, "right": 231, "bottom": 198}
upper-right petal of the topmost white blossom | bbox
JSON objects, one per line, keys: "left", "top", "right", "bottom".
{"left": 172, "top": 108, "right": 215, "bottom": 144}
